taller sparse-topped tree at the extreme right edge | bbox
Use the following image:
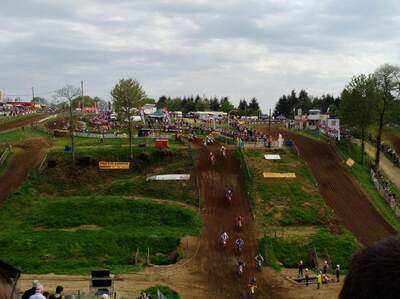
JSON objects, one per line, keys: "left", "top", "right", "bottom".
{"left": 374, "top": 64, "right": 400, "bottom": 169}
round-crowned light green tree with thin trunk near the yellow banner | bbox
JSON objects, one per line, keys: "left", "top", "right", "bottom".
{"left": 111, "top": 79, "right": 146, "bottom": 161}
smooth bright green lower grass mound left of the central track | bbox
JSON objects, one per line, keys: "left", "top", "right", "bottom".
{"left": 0, "top": 191, "right": 201, "bottom": 274}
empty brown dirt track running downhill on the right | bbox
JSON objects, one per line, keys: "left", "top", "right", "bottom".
{"left": 281, "top": 131, "right": 396, "bottom": 245}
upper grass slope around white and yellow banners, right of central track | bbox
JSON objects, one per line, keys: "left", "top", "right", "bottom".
{"left": 245, "top": 150, "right": 332, "bottom": 226}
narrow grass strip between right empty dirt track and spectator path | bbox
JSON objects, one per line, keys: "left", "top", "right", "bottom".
{"left": 338, "top": 140, "right": 400, "bottom": 230}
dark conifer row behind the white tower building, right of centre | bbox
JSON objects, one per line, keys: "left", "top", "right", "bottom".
{"left": 273, "top": 90, "right": 340, "bottom": 118}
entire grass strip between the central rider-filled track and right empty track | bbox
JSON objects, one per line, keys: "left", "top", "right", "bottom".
{"left": 245, "top": 149, "right": 360, "bottom": 269}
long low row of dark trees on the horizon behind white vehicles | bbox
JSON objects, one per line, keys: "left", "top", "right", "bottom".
{"left": 157, "top": 95, "right": 261, "bottom": 116}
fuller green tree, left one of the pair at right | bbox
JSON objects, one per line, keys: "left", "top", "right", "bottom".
{"left": 340, "top": 74, "right": 376, "bottom": 163}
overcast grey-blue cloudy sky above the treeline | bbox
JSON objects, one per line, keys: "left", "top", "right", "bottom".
{"left": 0, "top": 0, "right": 400, "bottom": 109}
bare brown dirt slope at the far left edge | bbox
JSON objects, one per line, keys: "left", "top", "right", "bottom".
{"left": 0, "top": 138, "right": 51, "bottom": 205}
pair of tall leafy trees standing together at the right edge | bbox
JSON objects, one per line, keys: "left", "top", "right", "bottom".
{"left": 340, "top": 64, "right": 400, "bottom": 169}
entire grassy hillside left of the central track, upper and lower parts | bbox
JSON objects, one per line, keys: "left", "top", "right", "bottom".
{"left": 0, "top": 146, "right": 201, "bottom": 274}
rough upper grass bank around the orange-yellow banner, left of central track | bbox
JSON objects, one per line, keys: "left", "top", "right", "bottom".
{"left": 29, "top": 147, "right": 197, "bottom": 205}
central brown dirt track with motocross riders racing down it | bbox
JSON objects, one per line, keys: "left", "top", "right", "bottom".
{"left": 197, "top": 147, "right": 282, "bottom": 298}
